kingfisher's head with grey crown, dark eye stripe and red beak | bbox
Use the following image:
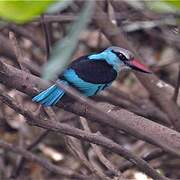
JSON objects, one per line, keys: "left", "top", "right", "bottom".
{"left": 102, "top": 46, "right": 151, "bottom": 73}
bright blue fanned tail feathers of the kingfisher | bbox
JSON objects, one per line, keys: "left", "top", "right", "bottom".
{"left": 32, "top": 81, "right": 67, "bottom": 107}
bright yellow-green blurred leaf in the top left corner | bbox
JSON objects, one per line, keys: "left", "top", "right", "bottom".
{"left": 0, "top": 0, "right": 54, "bottom": 23}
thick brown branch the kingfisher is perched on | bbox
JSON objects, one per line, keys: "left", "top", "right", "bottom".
{"left": 0, "top": 61, "right": 180, "bottom": 156}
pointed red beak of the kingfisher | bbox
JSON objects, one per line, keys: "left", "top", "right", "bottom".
{"left": 128, "top": 59, "right": 152, "bottom": 73}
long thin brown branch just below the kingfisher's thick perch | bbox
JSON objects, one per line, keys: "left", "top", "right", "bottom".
{"left": 0, "top": 91, "right": 168, "bottom": 180}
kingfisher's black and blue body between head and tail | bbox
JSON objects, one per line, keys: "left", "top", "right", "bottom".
{"left": 59, "top": 56, "right": 117, "bottom": 96}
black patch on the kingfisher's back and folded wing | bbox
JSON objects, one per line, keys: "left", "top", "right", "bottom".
{"left": 59, "top": 56, "right": 117, "bottom": 84}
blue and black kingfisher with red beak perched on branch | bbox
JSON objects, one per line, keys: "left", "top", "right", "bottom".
{"left": 32, "top": 46, "right": 151, "bottom": 107}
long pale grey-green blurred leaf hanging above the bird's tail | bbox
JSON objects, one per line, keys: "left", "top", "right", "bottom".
{"left": 43, "top": 1, "right": 94, "bottom": 80}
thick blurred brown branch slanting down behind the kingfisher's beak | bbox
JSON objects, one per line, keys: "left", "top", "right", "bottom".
{"left": 93, "top": 1, "right": 180, "bottom": 130}
